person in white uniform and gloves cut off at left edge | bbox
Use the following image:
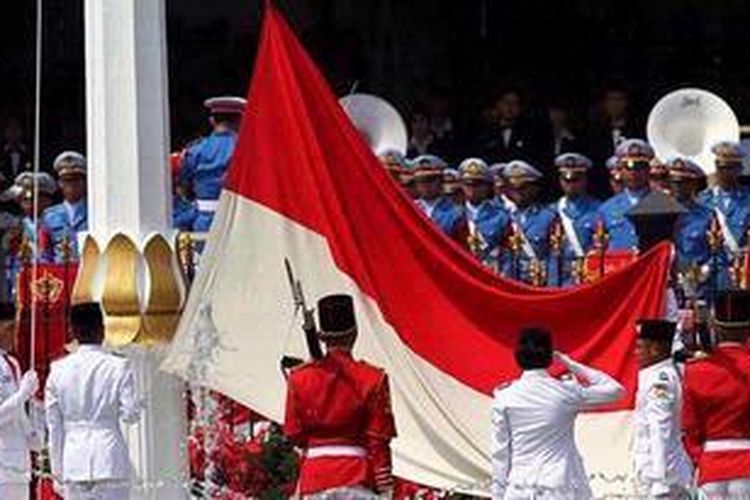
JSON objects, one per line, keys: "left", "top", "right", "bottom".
{"left": 0, "top": 304, "right": 39, "bottom": 500}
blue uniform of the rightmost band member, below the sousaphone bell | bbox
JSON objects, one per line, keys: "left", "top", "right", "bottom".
{"left": 698, "top": 187, "right": 750, "bottom": 290}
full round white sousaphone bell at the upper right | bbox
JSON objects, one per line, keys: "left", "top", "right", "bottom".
{"left": 646, "top": 88, "right": 740, "bottom": 175}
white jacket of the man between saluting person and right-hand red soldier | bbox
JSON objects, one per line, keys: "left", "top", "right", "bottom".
{"left": 634, "top": 359, "right": 693, "bottom": 495}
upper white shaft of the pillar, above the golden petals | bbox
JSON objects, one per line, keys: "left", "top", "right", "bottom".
{"left": 85, "top": 0, "right": 171, "bottom": 241}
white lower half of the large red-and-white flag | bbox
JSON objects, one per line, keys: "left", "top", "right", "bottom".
{"left": 162, "top": 191, "right": 630, "bottom": 494}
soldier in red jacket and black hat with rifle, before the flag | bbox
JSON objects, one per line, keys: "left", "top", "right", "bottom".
{"left": 284, "top": 295, "right": 396, "bottom": 500}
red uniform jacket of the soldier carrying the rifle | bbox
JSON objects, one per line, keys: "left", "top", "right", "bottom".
{"left": 284, "top": 351, "right": 396, "bottom": 495}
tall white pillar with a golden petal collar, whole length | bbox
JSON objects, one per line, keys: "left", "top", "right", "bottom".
{"left": 81, "top": 0, "right": 188, "bottom": 500}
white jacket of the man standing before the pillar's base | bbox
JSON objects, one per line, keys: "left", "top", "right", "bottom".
{"left": 45, "top": 345, "right": 139, "bottom": 481}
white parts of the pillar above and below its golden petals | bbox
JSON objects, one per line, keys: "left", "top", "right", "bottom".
{"left": 85, "top": 0, "right": 188, "bottom": 500}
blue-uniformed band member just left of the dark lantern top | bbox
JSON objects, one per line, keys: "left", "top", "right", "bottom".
{"left": 599, "top": 139, "right": 654, "bottom": 250}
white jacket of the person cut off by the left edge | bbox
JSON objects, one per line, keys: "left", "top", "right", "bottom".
{"left": 0, "top": 350, "right": 33, "bottom": 483}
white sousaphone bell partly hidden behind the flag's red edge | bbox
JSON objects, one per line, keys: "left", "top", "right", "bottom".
{"left": 339, "top": 94, "right": 408, "bottom": 156}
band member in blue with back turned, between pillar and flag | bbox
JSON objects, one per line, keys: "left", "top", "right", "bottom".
{"left": 180, "top": 97, "right": 246, "bottom": 232}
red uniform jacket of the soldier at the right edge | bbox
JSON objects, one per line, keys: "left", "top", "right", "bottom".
{"left": 682, "top": 344, "right": 750, "bottom": 485}
